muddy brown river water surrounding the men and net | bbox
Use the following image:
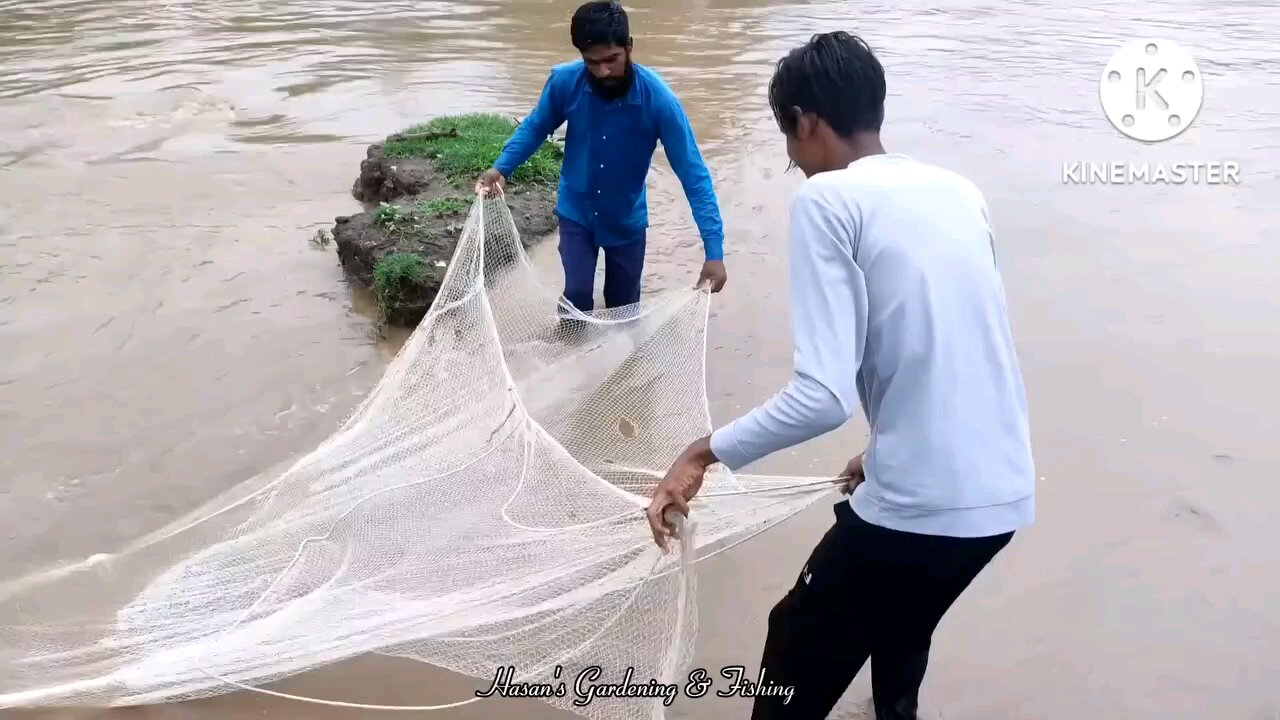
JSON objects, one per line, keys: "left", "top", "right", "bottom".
{"left": 0, "top": 0, "right": 1280, "bottom": 720}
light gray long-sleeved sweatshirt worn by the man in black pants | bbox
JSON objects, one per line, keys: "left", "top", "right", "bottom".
{"left": 710, "top": 154, "right": 1034, "bottom": 537}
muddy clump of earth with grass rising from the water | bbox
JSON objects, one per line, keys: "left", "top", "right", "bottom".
{"left": 333, "top": 114, "right": 563, "bottom": 327}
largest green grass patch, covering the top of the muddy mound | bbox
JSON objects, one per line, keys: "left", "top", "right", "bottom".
{"left": 383, "top": 114, "right": 564, "bottom": 186}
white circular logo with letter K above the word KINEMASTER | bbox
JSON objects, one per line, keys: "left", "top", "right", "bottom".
{"left": 1100, "top": 38, "right": 1204, "bottom": 142}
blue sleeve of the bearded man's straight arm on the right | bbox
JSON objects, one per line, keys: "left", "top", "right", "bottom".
{"left": 658, "top": 95, "right": 724, "bottom": 260}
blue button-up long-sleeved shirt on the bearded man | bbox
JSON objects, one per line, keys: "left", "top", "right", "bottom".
{"left": 494, "top": 60, "right": 724, "bottom": 260}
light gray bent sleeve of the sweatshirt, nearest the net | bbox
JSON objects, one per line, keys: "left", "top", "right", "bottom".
{"left": 710, "top": 183, "right": 868, "bottom": 470}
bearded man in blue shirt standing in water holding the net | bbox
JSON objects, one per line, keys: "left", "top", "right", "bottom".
{"left": 476, "top": 1, "right": 727, "bottom": 311}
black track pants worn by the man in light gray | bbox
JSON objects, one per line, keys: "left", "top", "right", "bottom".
{"left": 751, "top": 500, "right": 1012, "bottom": 720}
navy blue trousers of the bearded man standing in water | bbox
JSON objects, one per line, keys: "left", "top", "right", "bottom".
{"left": 559, "top": 218, "right": 646, "bottom": 313}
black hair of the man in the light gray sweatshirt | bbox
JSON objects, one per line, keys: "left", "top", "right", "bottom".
{"left": 769, "top": 31, "right": 884, "bottom": 138}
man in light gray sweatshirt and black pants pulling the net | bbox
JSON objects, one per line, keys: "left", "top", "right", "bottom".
{"left": 649, "top": 32, "right": 1034, "bottom": 720}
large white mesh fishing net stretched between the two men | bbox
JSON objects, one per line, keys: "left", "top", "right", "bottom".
{"left": 0, "top": 197, "right": 831, "bottom": 720}
